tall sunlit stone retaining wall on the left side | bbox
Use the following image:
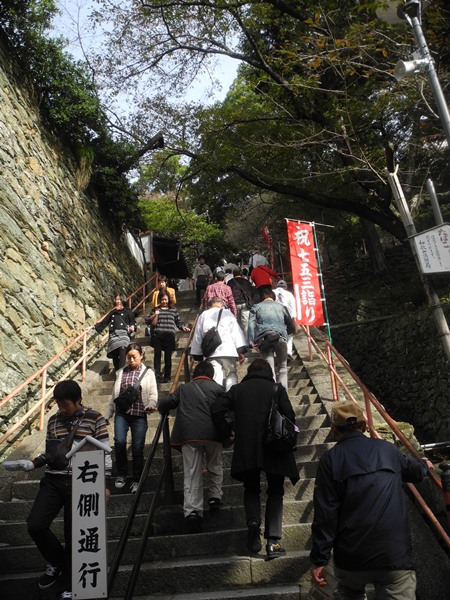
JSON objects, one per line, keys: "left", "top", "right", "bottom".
{"left": 0, "top": 31, "right": 143, "bottom": 398}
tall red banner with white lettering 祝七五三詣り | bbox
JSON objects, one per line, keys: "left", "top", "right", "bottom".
{"left": 286, "top": 220, "right": 325, "bottom": 326}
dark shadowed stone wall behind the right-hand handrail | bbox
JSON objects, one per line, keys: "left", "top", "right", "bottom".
{"left": 332, "top": 306, "right": 450, "bottom": 441}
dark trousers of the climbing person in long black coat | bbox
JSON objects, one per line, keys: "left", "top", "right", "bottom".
{"left": 243, "top": 469, "right": 284, "bottom": 540}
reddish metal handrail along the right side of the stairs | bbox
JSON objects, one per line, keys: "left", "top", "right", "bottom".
{"left": 300, "top": 325, "right": 450, "bottom": 549}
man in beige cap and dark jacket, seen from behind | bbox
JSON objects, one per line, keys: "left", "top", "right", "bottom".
{"left": 310, "top": 400, "right": 432, "bottom": 600}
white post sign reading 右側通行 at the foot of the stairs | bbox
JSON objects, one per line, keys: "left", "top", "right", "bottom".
{"left": 72, "top": 444, "right": 108, "bottom": 599}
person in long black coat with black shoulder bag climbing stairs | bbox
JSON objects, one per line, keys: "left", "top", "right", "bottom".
{"left": 211, "top": 358, "right": 299, "bottom": 560}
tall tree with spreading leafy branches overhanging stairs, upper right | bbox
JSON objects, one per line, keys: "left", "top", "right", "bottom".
{"left": 89, "top": 0, "right": 448, "bottom": 248}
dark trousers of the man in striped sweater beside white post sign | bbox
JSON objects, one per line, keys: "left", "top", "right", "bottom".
{"left": 27, "top": 474, "right": 72, "bottom": 581}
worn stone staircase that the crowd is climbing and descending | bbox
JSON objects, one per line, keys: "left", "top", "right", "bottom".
{"left": 0, "top": 292, "right": 448, "bottom": 600}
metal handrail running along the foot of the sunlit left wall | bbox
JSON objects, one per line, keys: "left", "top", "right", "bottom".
{"left": 0, "top": 274, "right": 158, "bottom": 444}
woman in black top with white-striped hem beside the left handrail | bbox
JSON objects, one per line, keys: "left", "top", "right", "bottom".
{"left": 94, "top": 293, "right": 137, "bottom": 371}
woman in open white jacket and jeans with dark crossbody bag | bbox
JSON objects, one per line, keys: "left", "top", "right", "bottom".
{"left": 105, "top": 343, "right": 158, "bottom": 494}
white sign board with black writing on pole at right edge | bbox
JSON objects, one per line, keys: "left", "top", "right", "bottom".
{"left": 413, "top": 223, "right": 450, "bottom": 275}
